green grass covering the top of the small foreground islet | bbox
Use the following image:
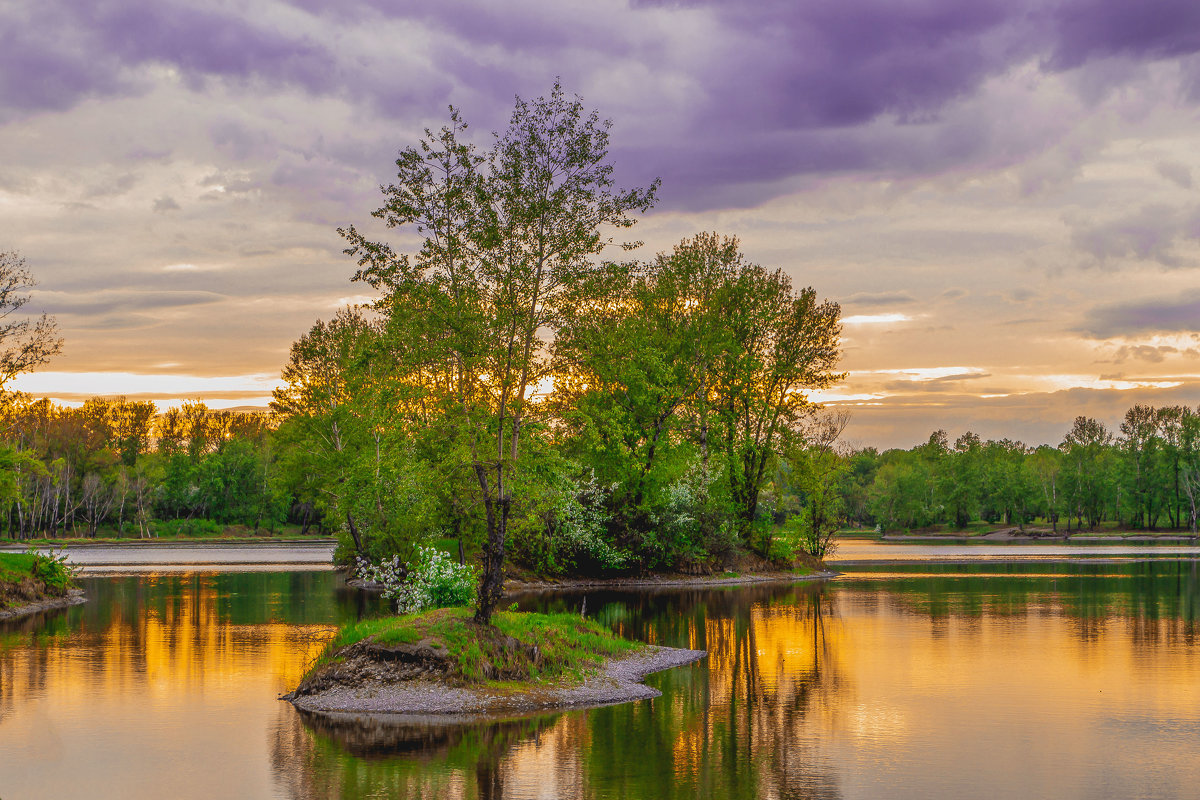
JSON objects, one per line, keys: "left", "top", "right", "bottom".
{"left": 308, "top": 608, "right": 642, "bottom": 684}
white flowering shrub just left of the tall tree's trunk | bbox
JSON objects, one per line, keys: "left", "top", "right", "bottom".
{"left": 358, "top": 547, "right": 475, "bottom": 614}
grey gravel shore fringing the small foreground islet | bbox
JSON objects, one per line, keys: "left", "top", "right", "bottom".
{"left": 283, "top": 645, "right": 708, "bottom": 717}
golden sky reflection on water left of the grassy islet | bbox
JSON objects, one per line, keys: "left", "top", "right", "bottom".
{"left": 0, "top": 575, "right": 336, "bottom": 798}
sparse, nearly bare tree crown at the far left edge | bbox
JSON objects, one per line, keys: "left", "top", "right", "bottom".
{"left": 0, "top": 251, "right": 62, "bottom": 398}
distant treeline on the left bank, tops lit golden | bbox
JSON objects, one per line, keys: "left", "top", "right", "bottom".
{"left": 0, "top": 397, "right": 295, "bottom": 539}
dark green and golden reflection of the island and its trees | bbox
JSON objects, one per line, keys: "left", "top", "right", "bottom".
{"left": 271, "top": 585, "right": 845, "bottom": 800}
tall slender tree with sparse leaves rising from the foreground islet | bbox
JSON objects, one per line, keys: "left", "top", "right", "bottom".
{"left": 341, "top": 82, "right": 658, "bottom": 624}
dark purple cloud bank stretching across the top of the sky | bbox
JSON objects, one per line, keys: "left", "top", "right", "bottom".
{"left": 7, "top": 0, "right": 1200, "bottom": 209}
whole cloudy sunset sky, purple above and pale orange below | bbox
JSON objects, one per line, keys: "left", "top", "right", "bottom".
{"left": 0, "top": 0, "right": 1200, "bottom": 447}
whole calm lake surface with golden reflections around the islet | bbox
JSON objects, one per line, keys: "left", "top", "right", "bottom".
{"left": 0, "top": 558, "right": 1200, "bottom": 800}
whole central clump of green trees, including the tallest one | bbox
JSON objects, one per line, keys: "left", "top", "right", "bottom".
{"left": 275, "top": 83, "right": 854, "bottom": 621}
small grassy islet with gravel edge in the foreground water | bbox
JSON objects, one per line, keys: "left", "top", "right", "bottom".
{"left": 283, "top": 608, "right": 707, "bottom": 718}
